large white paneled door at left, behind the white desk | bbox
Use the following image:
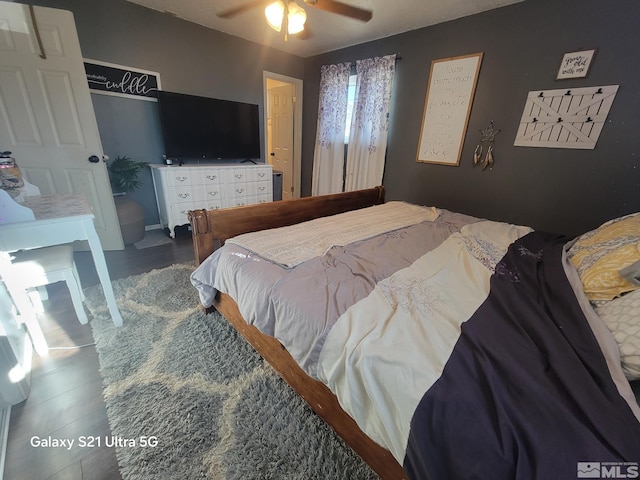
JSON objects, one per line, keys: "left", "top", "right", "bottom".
{"left": 0, "top": 1, "right": 123, "bottom": 250}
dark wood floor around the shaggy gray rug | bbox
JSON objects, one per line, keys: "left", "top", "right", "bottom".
{"left": 0, "top": 228, "right": 193, "bottom": 480}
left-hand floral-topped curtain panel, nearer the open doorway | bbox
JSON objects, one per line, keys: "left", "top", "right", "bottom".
{"left": 311, "top": 63, "right": 351, "bottom": 195}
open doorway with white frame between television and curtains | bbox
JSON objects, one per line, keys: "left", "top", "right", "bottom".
{"left": 263, "top": 71, "right": 302, "bottom": 200}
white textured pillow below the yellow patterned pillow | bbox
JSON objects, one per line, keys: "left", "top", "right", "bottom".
{"left": 596, "top": 290, "right": 640, "bottom": 380}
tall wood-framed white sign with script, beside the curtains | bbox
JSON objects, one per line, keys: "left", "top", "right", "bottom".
{"left": 417, "top": 53, "right": 482, "bottom": 166}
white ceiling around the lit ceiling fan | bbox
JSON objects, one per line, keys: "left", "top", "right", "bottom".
{"left": 127, "top": 0, "right": 523, "bottom": 57}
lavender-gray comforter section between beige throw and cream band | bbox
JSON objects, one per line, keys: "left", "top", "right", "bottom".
{"left": 191, "top": 210, "right": 479, "bottom": 378}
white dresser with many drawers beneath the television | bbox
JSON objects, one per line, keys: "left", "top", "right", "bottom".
{"left": 149, "top": 164, "right": 273, "bottom": 238}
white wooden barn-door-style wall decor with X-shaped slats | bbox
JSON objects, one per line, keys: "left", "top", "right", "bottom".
{"left": 513, "top": 85, "right": 618, "bottom": 149}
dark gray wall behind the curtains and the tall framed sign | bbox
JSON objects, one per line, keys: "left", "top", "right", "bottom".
{"left": 302, "top": 0, "right": 640, "bottom": 235}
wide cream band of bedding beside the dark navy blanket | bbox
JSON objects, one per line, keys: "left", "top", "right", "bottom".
{"left": 318, "top": 221, "right": 531, "bottom": 464}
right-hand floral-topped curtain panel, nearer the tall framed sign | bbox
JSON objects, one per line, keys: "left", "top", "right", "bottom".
{"left": 345, "top": 55, "right": 396, "bottom": 191}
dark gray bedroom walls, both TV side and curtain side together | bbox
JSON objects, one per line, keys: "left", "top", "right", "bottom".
{"left": 21, "top": 0, "right": 640, "bottom": 235}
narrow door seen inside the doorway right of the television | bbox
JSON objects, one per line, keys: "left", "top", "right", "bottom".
{"left": 269, "top": 84, "right": 293, "bottom": 200}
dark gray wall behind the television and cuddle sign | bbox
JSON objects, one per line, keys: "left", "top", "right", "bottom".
{"left": 25, "top": 0, "right": 304, "bottom": 225}
